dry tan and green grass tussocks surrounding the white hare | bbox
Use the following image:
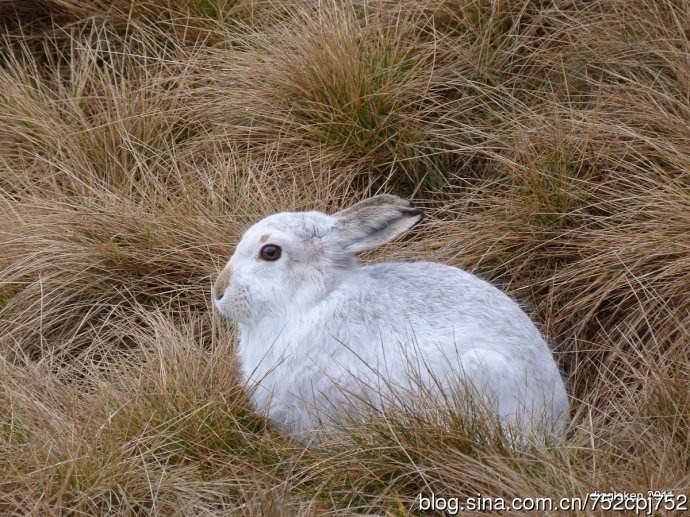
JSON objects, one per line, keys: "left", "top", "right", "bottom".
{"left": 0, "top": 0, "right": 690, "bottom": 515}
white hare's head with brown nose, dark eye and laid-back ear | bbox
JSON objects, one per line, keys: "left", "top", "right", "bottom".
{"left": 213, "top": 194, "right": 422, "bottom": 324}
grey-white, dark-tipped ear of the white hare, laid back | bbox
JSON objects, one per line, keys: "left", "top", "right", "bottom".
{"left": 333, "top": 194, "right": 424, "bottom": 253}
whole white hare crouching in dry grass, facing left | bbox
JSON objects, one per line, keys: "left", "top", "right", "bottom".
{"left": 213, "top": 194, "right": 568, "bottom": 436}
